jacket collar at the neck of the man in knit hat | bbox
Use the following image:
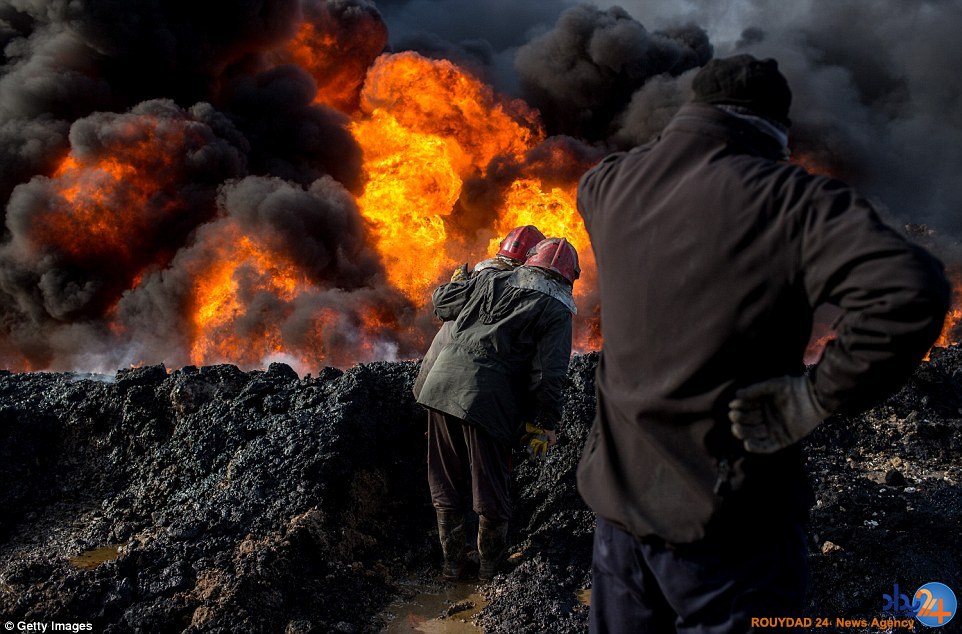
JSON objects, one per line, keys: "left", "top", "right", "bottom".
{"left": 662, "top": 103, "right": 783, "bottom": 160}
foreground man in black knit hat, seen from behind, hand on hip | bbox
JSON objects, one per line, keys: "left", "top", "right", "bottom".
{"left": 578, "top": 55, "right": 948, "bottom": 632}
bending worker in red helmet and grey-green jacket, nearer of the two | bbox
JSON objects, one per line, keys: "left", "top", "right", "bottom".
{"left": 417, "top": 238, "right": 580, "bottom": 580}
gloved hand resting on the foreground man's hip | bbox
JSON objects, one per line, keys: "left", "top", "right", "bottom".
{"left": 728, "top": 376, "right": 830, "bottom": 453}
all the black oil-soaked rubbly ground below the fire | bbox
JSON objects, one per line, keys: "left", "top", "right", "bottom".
{"left": 0, "top": 348, "right": 962, "bottom": 633}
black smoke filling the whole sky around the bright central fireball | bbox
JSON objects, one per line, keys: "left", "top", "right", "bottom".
{"left": 0, "top": 0, "right": 962, "bottom": 371}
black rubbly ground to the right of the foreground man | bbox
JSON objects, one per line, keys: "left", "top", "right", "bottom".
{"left": 807, "top": 346, "right": 962, "bottom": 631}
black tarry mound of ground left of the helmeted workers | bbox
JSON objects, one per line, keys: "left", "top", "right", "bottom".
{"left": 0, "top": 363, "right": 433, "bottom": 632}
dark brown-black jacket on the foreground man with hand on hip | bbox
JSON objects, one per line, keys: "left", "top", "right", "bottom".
{"left": 578, "top": 104, "right": 948, "bottom": 542}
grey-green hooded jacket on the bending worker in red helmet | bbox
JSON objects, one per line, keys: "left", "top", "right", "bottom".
{"left": 417, "top": 266, "right": 571, "bottom": 444}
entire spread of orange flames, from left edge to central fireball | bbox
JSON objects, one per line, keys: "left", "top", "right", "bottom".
{"left": 0, "top": 12, "right": 960, "bottom": 371}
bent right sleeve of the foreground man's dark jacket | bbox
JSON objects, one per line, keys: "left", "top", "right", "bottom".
{"left": 799, "top": 179, "right": 949, "bottom": 411}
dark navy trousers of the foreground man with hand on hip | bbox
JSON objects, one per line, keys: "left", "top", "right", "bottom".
{"left": 590, "top": 517, "right": 808, "bottom": 634}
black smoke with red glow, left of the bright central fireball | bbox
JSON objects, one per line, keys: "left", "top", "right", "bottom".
{"left": 0, "top": 0, "right": 410, "bottom": 370}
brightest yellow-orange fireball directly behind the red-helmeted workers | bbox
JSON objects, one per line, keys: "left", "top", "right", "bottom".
{"left": 351, "top": 53, "right": 600, "bottom": 350}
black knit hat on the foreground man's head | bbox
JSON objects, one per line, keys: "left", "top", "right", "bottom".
{"left": 691, "top": 55, "right": 792, "bottom": 127}
